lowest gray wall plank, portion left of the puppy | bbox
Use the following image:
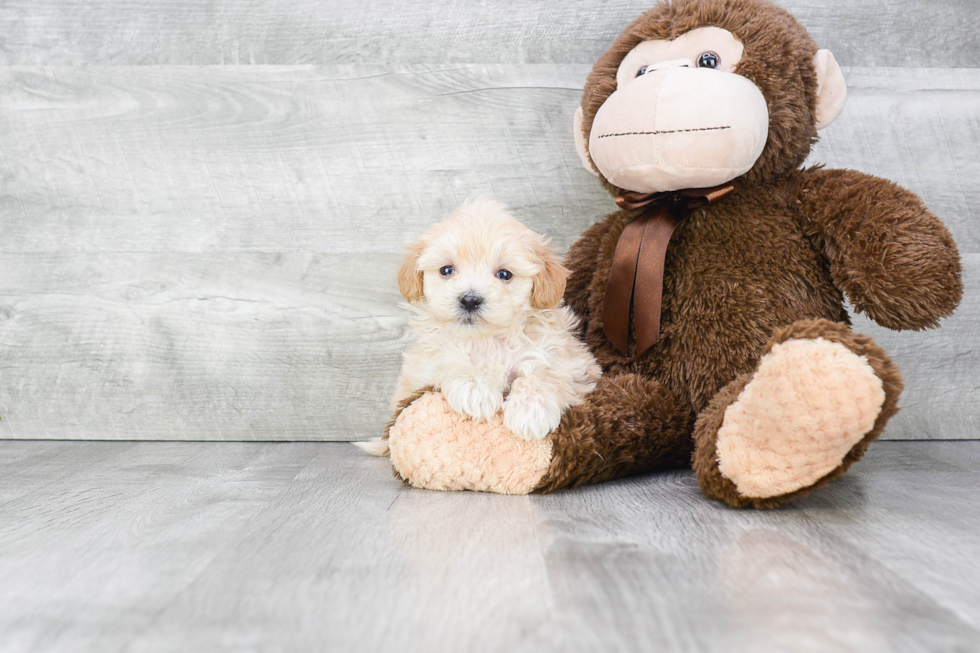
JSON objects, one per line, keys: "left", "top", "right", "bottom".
{"left": 0, "top": 253, "right": 408, "bottom": 440}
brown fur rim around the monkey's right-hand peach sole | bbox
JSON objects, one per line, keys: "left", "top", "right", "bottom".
{"left": 694, "top": 320, "right": 903, "bottom": 508}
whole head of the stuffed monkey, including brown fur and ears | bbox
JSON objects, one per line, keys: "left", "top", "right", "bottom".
{"left": 575, "top": 0, "right": 846, "bottom": 193}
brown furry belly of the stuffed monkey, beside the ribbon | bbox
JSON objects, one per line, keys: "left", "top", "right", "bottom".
{"left": 590, "top": 215, "right": 848, "bottom": 410}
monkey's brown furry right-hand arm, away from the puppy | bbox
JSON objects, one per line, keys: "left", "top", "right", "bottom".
{"left": 795, "top": 169, "right": 963, "bottom": 330}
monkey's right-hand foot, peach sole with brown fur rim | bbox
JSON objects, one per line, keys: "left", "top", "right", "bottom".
{"left": 695, "top": 321, "right": 901, "bottom": 507}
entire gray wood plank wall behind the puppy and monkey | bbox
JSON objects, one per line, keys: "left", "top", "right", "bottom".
{"left": 0, "top": 0, "right": 980, "bottom": 440}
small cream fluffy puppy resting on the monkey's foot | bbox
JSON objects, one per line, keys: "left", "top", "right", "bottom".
{"left": 358, "top": 199, "right": 601, "bottom": 455}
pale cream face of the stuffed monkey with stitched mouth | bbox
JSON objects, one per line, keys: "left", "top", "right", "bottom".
{"left": 589, "top": 27, "right": 769, "bottom": 193}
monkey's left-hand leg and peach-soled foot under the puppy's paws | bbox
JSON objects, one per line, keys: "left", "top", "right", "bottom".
{"left": 378, "top": 374, "right": 693, "bottom": 494}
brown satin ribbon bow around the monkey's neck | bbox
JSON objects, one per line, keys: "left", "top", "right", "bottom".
{"left": 602, "top": 185, "right": 732, "bottom": 356}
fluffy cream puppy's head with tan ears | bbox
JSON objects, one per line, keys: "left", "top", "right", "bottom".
{"left": 398, "top": 199, "right": 568, "bottom": 331}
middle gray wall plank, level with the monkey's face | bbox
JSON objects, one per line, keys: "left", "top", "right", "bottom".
{"left": 0, "top": 65, "right": 980, "bottom": 253}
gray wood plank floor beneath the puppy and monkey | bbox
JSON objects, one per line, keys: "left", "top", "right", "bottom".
{"left": 0, "top": 441, "right": 980, "bottom": 653}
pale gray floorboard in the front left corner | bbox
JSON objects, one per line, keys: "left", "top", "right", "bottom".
{"left": 0, "top": 443, "right": 316, "bottom": 652}
